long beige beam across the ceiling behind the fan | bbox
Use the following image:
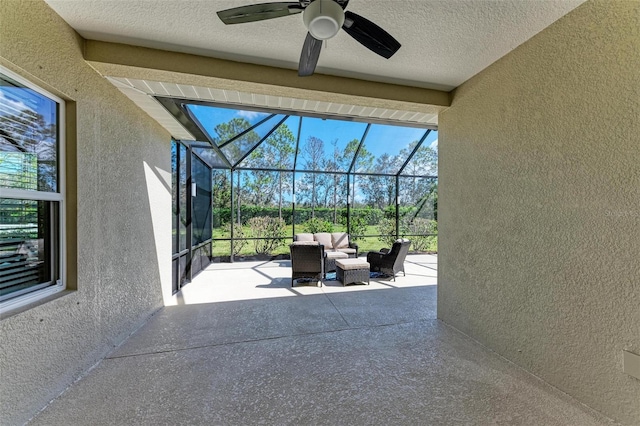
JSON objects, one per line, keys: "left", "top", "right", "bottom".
{"left": 84, "top": 40, "right": 450, "bottom": 114}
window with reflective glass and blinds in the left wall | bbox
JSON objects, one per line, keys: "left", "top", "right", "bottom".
{"left": 0, "top": 67, "right": 64, "bottom": 311}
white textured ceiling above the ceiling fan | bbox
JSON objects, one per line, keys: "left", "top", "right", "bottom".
{"left": 45, "top": 0, "right": 584, "bottom": 91}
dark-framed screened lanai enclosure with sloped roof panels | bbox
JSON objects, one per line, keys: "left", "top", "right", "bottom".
{"left": 169, "top": 98, "right": 438, "bottom": 291}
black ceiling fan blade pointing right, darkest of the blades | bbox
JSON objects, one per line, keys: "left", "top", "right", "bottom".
{"left": 342, "top": 11, "right": 401, "bottom": 59}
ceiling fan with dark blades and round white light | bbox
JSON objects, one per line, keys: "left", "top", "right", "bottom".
{"left": 218, "top": 0, "right": 400, "bottom": 77}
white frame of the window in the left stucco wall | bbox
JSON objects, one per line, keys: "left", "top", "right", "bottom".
{"left": 0, "top": 65, "right": 67, "bottom": 314}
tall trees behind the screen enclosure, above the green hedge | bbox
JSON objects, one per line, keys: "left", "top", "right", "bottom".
{"left": 212, "top": 117, "right": 437, "bottom": 223}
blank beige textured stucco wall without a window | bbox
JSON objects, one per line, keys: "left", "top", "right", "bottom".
{"left": 438, "top": 0, "right": 640, "bottom": 425}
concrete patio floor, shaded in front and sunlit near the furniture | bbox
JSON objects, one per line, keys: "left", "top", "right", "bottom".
{"left": 31, "top": 255, "right": 611, "bottom": 426}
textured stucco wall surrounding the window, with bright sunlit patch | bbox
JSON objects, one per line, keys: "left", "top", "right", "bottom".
{"left": 0, "top": 0, "right": 171, "bottom": 424}
